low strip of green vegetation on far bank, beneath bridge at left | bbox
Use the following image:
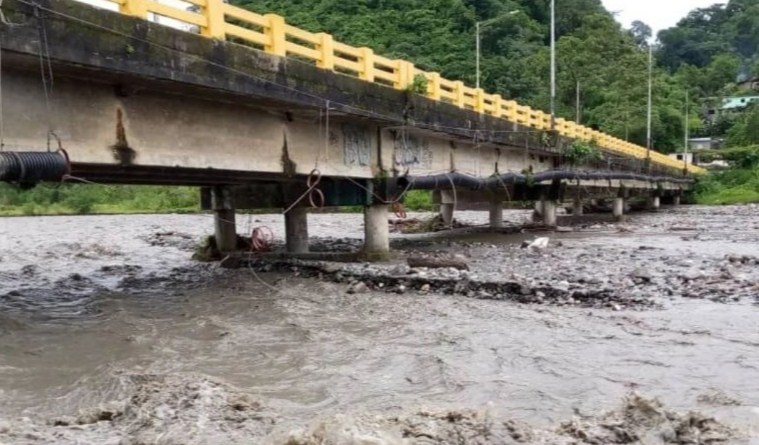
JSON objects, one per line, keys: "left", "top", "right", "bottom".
{"left": 0, "top": 184, "right": 200, "bottom": 216}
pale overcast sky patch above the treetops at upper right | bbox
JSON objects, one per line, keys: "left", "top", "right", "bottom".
{"left": 602, "top": 0, "right": 727, "bottom": 36}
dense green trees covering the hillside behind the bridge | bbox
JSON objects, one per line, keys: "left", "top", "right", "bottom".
{"left": 232, "top": 0, "right": 759, "bottom": 152}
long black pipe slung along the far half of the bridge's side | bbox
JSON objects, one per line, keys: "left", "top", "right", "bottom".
{"left": 397, "top": 170, "right": 693, "bottom": 190}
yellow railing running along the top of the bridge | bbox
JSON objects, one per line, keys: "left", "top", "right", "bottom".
{"left": 95, "top": 0, "right": 704, "bottom": 173}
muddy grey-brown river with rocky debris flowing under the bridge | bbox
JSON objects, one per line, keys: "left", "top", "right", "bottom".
{"left": 0, "top": 207, "right": 759, "bottom": 444}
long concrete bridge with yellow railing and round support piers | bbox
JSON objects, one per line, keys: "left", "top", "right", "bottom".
{"left": 0, "top": 0, "right": 701, "bottom": 256}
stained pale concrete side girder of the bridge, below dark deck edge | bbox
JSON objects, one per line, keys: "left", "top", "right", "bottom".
{"left": 3, "top": 69, "right": 548, "bottom": 178}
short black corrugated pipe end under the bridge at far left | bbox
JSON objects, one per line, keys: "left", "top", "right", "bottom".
{"left": 0, "top": 150, "right": 69, "bottom": 187}
